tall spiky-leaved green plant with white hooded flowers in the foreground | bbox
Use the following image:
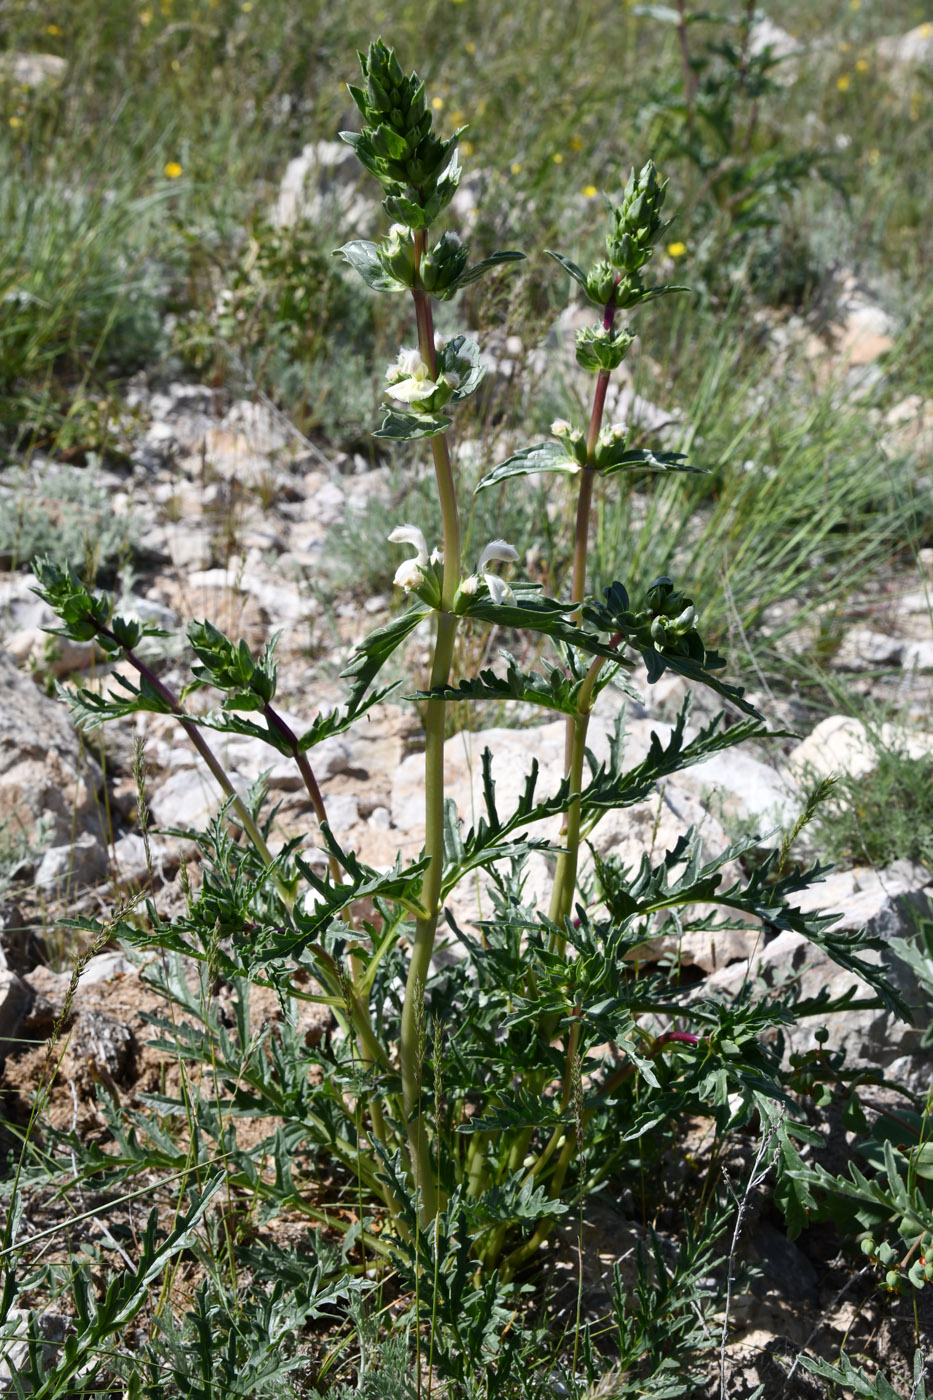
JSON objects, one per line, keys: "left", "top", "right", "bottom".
{"left": 32, "top": 41, "right": 888, "bottom": 1377}
